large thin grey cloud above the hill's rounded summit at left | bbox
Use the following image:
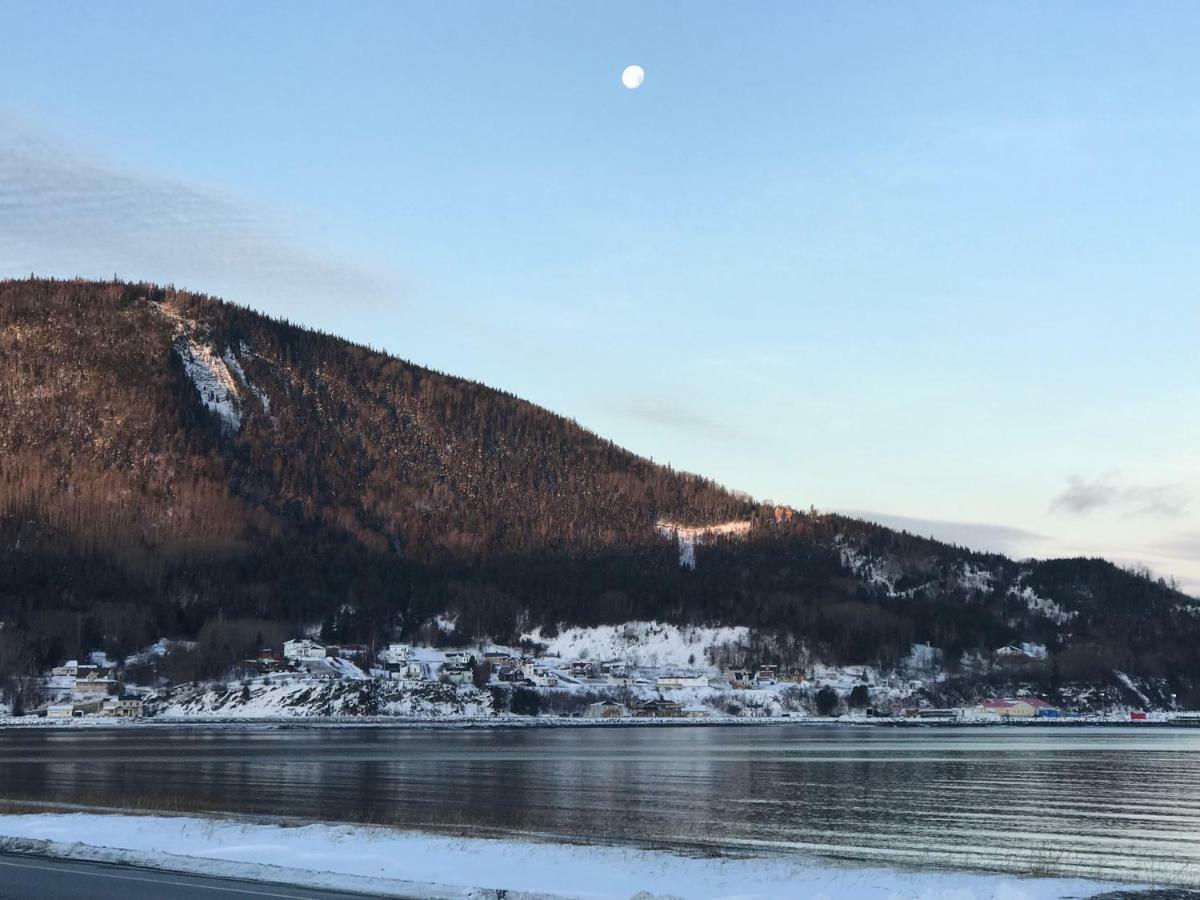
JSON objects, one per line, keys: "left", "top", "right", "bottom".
{"left": 0, "top": 122, "right": 385, "bottom": 314}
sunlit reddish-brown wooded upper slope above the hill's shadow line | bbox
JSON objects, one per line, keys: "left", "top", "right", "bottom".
{"left": 0, "top": 281, "right": 751, "bottom": 560}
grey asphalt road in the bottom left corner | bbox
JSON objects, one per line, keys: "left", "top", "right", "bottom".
{"left": 0, "top": 853, "right": 384, "bottom": 900}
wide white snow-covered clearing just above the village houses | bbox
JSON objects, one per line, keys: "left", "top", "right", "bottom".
{"left": 522, "top": 622, "right": 750, "bottom": 668}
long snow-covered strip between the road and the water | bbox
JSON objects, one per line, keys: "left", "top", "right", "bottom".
{"left": 0, "top": 814, "right": 1128, "bottom": 900}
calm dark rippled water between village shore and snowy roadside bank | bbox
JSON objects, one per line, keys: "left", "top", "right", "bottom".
{"left": 0, "top": 726, "right": 1200, "bottom": 881}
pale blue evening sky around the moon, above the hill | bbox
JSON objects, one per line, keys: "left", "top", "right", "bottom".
{"left": 0, "top": 0, "right": 1200, "bottom": 594}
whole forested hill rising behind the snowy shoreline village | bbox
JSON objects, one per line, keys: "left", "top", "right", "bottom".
{"left": 0, "top": 280, "right": 1200, "bottom": 696}
